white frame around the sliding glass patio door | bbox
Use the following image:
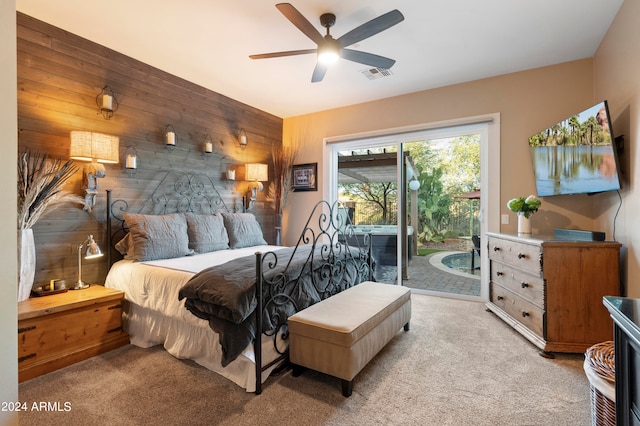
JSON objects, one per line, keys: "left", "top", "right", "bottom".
{"left": 322, "top": 113, "right": 501, "bottom": 301}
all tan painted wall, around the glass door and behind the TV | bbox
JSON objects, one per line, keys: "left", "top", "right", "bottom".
{"left": 283, "top": 0, "right": 640, "bottom": 298}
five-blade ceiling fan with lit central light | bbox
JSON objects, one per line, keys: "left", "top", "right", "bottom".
{"left": 249, "top": 3, "right": 404, "bottom": 83}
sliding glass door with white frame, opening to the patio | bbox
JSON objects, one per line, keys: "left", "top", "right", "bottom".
{"left": 325, "top": 117, "right": 499, "bottom": 300}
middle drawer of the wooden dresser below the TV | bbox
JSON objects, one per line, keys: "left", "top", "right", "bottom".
{"left": 490, "top": 260, "right": 544, "bottom": 308}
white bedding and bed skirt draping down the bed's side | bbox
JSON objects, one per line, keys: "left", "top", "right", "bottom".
{"left": 105, "top": 246, "right": 282, "bottom": 392}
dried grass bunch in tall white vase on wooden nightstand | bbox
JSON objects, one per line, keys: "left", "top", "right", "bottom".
{"left": 18, "top": 151, "right": 84, "bottom": 302}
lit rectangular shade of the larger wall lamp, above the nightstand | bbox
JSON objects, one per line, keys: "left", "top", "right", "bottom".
{"left": 69, "top": 130, "right": 120, "bottom": 164}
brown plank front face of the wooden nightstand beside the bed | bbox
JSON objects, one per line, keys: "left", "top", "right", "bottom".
{"left": 18, "top": 296, "right": 126, "bottom": 369}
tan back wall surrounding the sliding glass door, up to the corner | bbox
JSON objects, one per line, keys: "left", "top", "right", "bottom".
{"left": 283, "top": 59, "right": 596, "bottom": 240}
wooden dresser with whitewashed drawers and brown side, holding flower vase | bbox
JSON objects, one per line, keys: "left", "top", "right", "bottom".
{"left": 487, "top": 233, "right": 621, "bottom": 355}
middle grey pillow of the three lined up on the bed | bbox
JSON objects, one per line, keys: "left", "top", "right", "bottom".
{"left": 184, "top": 213, "right": 229, "bottom": 253}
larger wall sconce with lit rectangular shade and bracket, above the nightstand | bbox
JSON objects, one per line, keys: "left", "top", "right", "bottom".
{"left": 69, "top": 130, "right": 120, "bottom": 211}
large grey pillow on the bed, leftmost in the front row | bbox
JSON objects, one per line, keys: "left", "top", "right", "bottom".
{"left": 123, "top": 213, "right": 193, "bottom": 261}
